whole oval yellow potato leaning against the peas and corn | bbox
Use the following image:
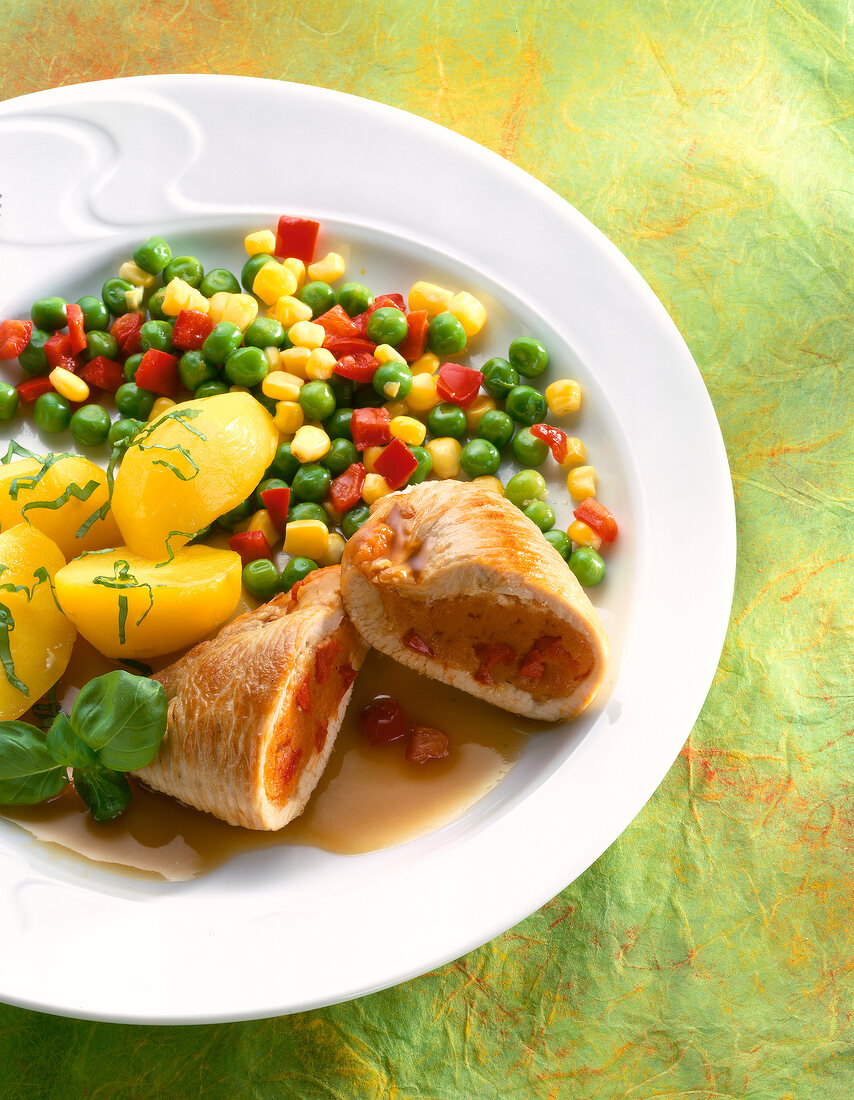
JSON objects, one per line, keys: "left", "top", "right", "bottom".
{"left": 112, "top": 393, "right": 278, "bottom": 561}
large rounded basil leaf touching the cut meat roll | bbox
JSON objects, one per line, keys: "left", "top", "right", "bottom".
{"left": 72, "top": 669, "right": 167, "bottom": 771}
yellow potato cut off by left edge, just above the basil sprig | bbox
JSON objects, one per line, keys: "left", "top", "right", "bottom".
{"left": 0, "top": 524, "right": 76, "bottom": 722}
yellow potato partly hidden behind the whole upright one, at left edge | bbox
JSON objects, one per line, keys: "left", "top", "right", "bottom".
{"left": 0, "top": 454, "right": 124, "bottom": 558}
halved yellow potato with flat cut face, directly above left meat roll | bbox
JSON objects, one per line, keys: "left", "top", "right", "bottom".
{"left": 55, "top": 546, "right": 242, "bottom": 659}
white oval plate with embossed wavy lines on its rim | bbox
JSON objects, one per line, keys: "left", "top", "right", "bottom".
{"left": 0, "top": 76, "right": 735, "bottom": 1023}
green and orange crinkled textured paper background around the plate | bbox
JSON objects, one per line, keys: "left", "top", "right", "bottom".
{"left": 0, "top": 0, "right": 854, "bottom": 1100}
